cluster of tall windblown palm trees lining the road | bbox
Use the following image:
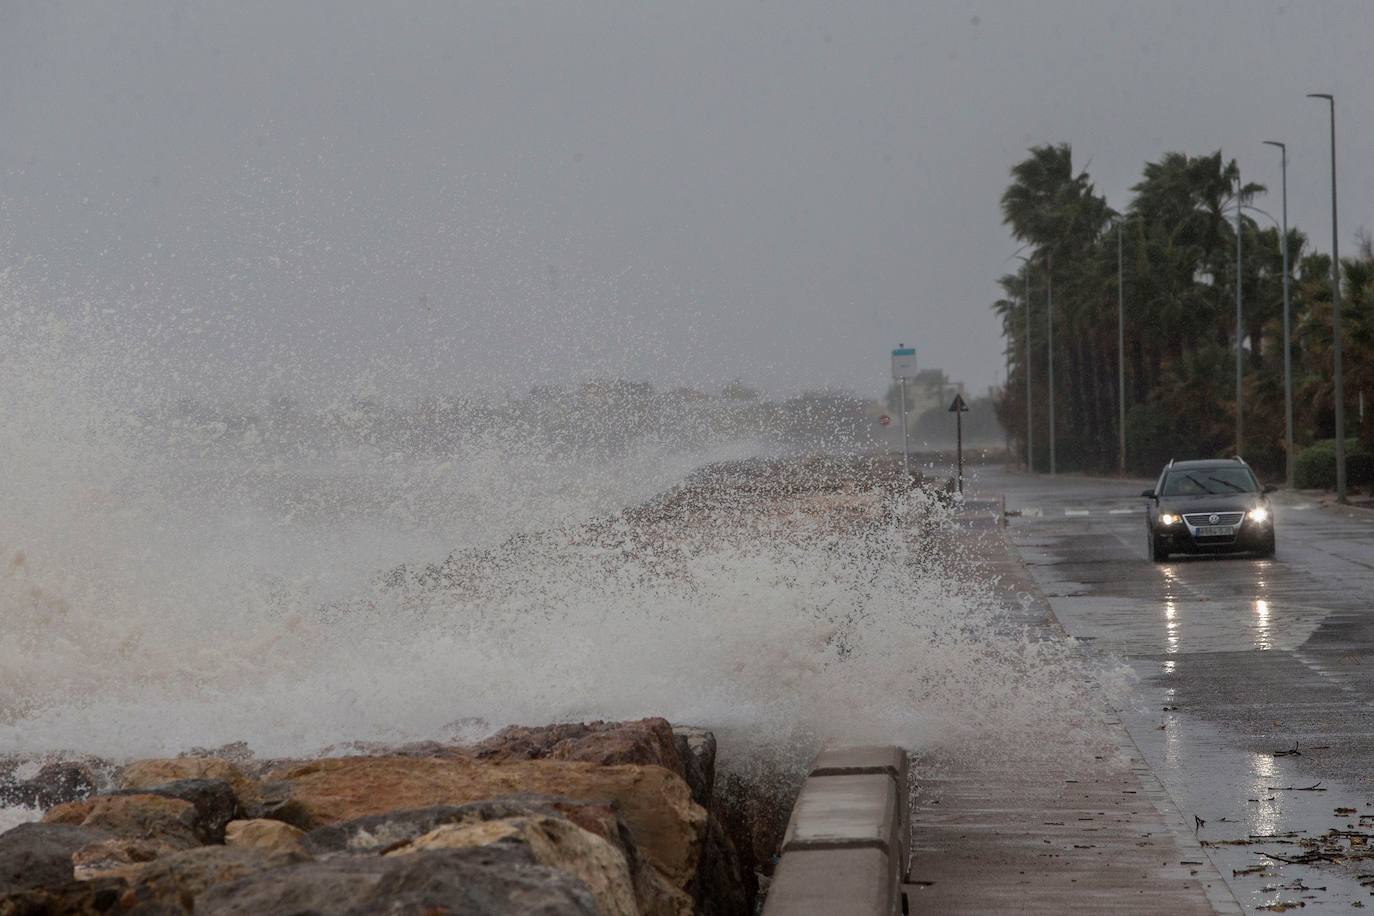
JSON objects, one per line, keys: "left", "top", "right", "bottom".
{"left": 993, "top": 143, "right": 1374, "bottom": 480}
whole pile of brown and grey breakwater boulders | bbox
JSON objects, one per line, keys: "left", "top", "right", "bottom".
{"left": 0, "top": 718, "right": 757, "bottom": 916}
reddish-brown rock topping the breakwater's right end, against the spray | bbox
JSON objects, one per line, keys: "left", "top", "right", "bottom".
{"left": 473, "top": 718, "right": 684, "bottom": 776}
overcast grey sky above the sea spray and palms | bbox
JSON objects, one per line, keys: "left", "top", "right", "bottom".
{"left": 0, "top": 0, "right": 1374, "bottom": 394}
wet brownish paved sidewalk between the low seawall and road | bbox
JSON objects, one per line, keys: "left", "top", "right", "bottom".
{"left": 910, "top": 505, "right": 1242, "bottom": 915}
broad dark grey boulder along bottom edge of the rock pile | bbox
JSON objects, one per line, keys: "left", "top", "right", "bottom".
{"left": 195, "top": 846, "right": 598, "bottom": 916}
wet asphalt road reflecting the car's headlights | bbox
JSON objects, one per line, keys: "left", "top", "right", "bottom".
{"left": 970, "top": 468, "right": 1374, "bottom": 912}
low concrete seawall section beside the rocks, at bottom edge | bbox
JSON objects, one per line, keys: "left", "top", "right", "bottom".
{"left": 763, "top": 744, "right": 911, "bottom": 916}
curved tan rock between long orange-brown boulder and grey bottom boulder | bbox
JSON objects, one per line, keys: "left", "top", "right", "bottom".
{"left": 387, "top": 816, "right": 639, "bottom": 916}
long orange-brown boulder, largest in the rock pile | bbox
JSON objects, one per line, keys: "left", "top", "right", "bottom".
{"left": 272, "top": 757, "right": 706, "bottom": 889}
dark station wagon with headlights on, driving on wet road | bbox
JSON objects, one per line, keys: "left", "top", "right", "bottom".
{"left": 1140, "top": 457, "right": 1274, "bottom": 563}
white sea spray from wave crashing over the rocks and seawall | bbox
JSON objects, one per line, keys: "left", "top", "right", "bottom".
{"left": 0, "top": 295, "right": 1110, "bottom": 774}
